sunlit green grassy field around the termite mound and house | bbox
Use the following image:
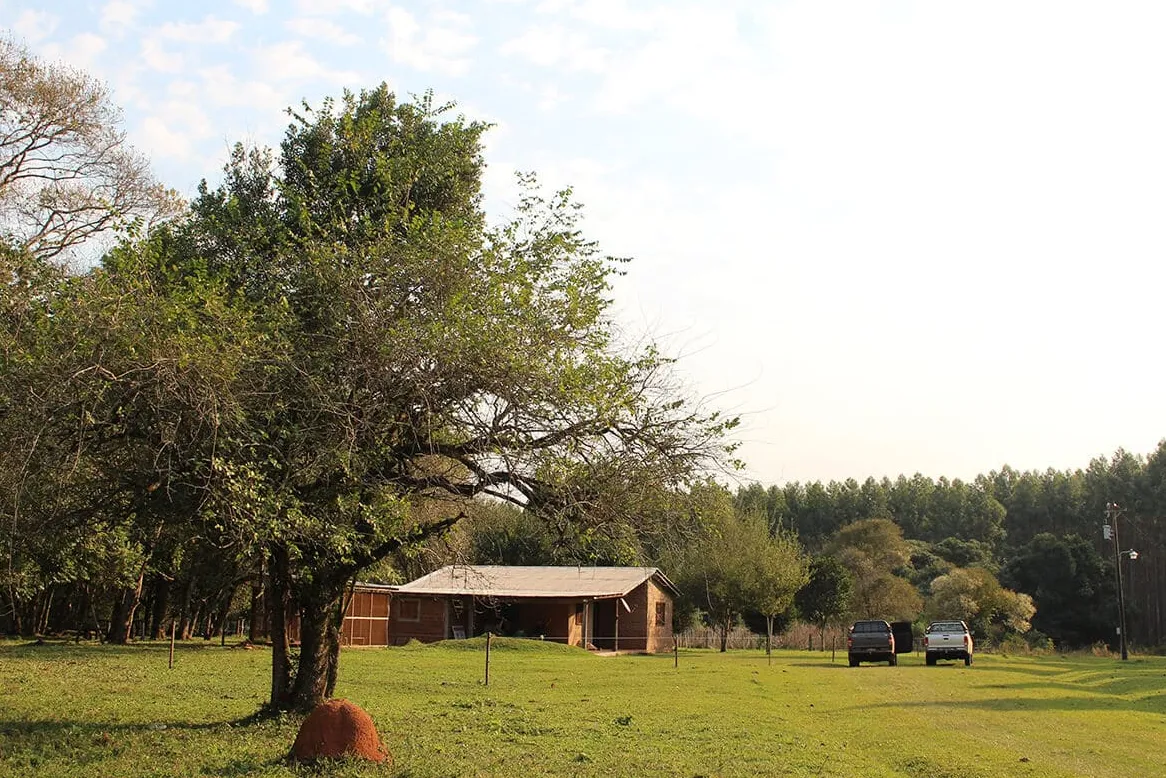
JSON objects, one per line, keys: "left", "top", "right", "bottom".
{"left": 0, "top": 640, "right": 1166, "bottom": 778}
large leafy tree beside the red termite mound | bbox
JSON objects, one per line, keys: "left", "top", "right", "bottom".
{"left": 70, "top": 87, "right": 735, "bottom": 709}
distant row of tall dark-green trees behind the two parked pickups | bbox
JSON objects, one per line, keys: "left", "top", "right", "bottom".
{"left": 735, "top": 441, "right": 1166, "bottom": 647}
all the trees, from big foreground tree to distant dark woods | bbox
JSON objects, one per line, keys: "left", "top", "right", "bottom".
{"left": 0, "top": 42, "right": 1166, "bottom": 709}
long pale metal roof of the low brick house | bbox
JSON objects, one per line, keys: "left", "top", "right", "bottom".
{"left": 396, "top": 565, "right": 679, "bottom": 600}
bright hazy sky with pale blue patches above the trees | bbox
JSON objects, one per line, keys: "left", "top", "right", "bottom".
{"left": 0, "top": 0, "right": 1166, "bottom": 485}
